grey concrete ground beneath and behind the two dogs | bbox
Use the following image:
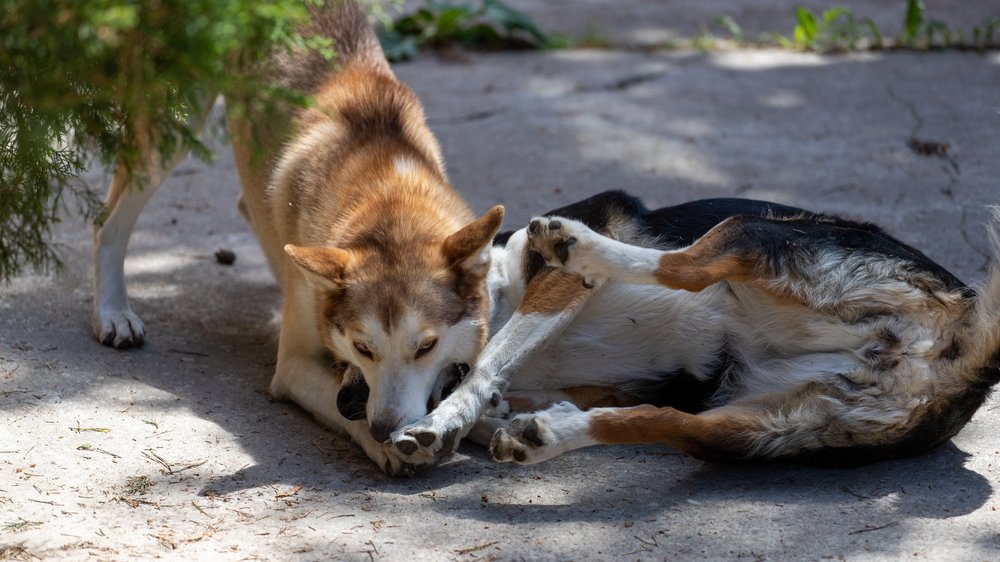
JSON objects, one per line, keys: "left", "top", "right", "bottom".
{"left": 0, "top": 0, "right": 1000, "bottom": 561}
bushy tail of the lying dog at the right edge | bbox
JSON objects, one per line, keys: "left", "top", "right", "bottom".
{"left": 940, "top": 207, "right": 1000, "bottom": 437}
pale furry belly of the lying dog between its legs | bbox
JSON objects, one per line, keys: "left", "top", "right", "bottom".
{"left": 510, "top": 283, "right": 876, "bottom": 407}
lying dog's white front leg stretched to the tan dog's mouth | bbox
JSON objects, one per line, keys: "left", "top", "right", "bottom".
{"left": 392, "top": 268, "right": 597, "bottom": 464}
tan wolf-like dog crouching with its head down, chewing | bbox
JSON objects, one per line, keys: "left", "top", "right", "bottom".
{"left": 93, "top": 0, "right": 503, "bottom": 474}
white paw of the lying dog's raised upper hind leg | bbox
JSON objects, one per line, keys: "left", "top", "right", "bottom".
{"left": 528, "top": 217, "right": 610, "bottom": 286}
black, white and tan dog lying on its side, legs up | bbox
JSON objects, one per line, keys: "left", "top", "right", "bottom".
{"left": 386, "top": 192, "right": 1000, "bottom": 466}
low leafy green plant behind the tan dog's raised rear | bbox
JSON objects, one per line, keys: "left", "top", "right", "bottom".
{"left": 379, "top": 0, "right": 548, "bottom": 61}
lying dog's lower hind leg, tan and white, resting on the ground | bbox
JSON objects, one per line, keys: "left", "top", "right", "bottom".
{"left": 490, "top": 376, "right": 912, "bottom": 466}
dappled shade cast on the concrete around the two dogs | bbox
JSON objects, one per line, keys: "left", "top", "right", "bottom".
{"left": 0, "top": 44, "right": 997, "bottom": 557}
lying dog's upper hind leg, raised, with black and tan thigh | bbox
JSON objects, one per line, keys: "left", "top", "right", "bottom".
{"left": 528, "top": 212, "right": 967, "bottom": 312}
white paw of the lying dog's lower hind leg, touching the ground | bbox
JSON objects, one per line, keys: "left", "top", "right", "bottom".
{"left": 490, "top": 402, "right": 587, "bottom": 464}
